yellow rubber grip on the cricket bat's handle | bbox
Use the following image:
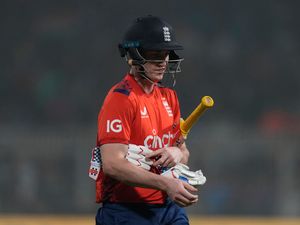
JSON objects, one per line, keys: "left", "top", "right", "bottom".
{"left": 180, "top": 96, "right": 214, "bottom": 137}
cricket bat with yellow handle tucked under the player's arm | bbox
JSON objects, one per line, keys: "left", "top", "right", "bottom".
{"left": 175, "top": 96, "right": 214, "bottom": 146}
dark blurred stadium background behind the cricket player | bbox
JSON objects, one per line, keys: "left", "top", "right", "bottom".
{"left": 0, "top": 0, "right": 300, "bottom": 224}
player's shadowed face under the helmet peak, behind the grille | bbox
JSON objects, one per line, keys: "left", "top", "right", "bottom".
{"left": 143, "top": 51, "right": 169, "bottom": 82}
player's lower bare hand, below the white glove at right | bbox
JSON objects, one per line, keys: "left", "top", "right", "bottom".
{"left": 166, "top": 178, "right": 198, "bottom": 207}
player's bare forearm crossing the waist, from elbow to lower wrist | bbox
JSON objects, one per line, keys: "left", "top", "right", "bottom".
{"left": 103, "top": 159, "right": 166, "bottom": 191}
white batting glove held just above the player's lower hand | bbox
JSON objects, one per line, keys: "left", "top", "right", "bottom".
{"left": 161, "top": 163, "right": 206, "bottom": 186}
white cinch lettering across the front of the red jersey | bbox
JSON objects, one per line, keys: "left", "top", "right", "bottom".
{"left": 144, "top": 132, "right": 174, "bottom": 149}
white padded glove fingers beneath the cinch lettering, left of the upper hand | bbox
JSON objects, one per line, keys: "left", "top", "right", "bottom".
{"left": 126, "top": 144, "right": 153, "bottom": 170}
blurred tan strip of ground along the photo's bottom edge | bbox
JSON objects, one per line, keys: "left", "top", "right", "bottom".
{"left": 0, "top": 215, "right": 300, "bottom": 225}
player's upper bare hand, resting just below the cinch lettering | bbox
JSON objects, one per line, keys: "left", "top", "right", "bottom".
{"left": 146, "top": 147, "right": 183, "bottom": 167}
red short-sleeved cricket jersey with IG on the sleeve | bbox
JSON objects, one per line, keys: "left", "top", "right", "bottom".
{"left": 96, "top": 74, "right": 181, "bottom": 204}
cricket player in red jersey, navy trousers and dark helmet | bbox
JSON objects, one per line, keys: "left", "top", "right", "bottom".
{"left": 92, "top": 16, "right": 198, "bottom": 225}
